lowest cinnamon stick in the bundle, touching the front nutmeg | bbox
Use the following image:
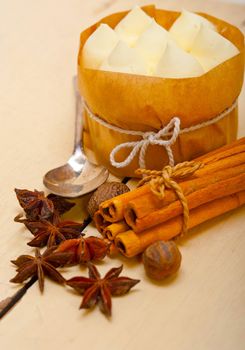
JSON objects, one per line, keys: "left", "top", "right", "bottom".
{"left": 115, "top": 191, "right": 245, "bottom": 257}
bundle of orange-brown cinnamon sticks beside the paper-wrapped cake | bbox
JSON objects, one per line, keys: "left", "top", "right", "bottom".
{"left": 94, "top": 137, "right": 245, "bottom": 257}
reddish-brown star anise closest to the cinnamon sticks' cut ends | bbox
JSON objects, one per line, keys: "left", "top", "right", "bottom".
{"left": 56, "top": 236, "right": 110, "bottom": 264}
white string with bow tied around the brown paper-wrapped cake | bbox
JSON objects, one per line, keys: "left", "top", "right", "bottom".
{"left": 83, "top": 100, "right": 237, "bottom": 168}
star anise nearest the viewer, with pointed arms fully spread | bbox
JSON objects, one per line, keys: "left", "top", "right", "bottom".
{"left": 66, "top": 263, "right": 140, "bottom": 316}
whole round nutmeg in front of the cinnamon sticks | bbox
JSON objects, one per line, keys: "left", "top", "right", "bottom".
{"left": 143, "top": 241, "right": 182, "bottom": 280}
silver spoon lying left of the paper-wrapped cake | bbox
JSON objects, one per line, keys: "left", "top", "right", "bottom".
{"left": 43, "top": 77, "right": 109, "bottom": 197}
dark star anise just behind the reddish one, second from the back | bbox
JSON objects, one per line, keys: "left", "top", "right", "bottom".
{"left": 15, "top": 214, "right": 84, "bottom": 247}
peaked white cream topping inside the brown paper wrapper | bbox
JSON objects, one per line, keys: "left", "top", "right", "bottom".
{"left": 82, "top": 7, "right": 239, "bottom": 78}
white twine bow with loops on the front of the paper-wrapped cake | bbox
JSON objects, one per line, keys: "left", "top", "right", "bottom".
{"left": 110, "top": 117, "right": 180, "bottom": 168}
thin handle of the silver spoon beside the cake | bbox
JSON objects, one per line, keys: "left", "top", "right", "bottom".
{"left": 73, "top": 76, "right": 84, "bottom": 154}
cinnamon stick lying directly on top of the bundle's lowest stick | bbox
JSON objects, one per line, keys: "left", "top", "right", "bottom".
{"left": 124, "top": 172, "right": 245, "bottom": 232}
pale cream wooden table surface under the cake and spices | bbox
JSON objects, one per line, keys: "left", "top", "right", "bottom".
{"left": 0, "top": 0, "right": 245, "bottom": 350}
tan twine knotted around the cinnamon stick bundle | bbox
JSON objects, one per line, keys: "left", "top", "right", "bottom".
{"left": 135, "top": 161, "right": 204, "bottom": 235}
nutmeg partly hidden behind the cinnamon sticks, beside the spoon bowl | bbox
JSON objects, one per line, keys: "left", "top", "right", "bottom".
{"left": 87, "top": 181, "right": 130, "bottom": 218}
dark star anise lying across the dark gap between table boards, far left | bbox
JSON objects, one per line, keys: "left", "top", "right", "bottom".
{"left": 10, "top": 247, "right": 72, "bottom": 292}
